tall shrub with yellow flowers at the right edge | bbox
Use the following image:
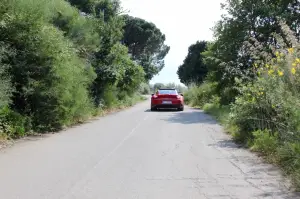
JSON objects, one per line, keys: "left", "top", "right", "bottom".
{"left": 231, "top": 48, "right": 300, "bottom": 140}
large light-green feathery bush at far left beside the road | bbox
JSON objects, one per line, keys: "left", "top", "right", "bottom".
{"left": 0, "top": 13, "right": 93, "bottom": 130}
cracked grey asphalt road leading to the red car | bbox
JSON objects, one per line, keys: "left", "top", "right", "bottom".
{"left": 0, "top": 98, "right": 300, "bottom": 199}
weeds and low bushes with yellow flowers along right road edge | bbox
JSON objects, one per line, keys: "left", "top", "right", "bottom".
{"left": 185, "top": 37, "right": 300, "bottom": 190}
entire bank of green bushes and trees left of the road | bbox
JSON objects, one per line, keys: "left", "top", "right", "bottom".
{"left": 0, "top": 0, "right": 170, "bottom": 139}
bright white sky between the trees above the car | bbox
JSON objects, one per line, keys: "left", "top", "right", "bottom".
{"left": 121, "top": 0, "right": 224, "bottom": 84}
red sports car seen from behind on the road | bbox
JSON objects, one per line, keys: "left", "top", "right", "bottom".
{"left": 151, "top": 89, "right": 184, "bottom": 111}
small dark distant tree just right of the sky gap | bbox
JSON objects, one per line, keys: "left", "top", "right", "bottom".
{"left": 177, "top": 41, "right": 208, "bottom": 84}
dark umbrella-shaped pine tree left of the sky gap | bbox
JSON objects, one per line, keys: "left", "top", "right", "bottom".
{"left": 123, "top": 15, "right": 170, "bottom": 81}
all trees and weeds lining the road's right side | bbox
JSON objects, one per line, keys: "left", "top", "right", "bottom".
{"left": 177, "top": 0, "right": 300, "bottom": 190}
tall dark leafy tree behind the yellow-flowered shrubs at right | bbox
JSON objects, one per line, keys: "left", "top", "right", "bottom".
{"left": 189, "top": 0, "right": 300, "bottom": 104}
